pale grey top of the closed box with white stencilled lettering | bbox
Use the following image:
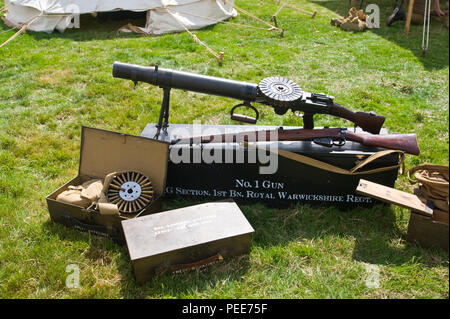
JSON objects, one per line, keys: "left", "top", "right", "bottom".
{"left": 122, "top": 199, "right": 254, "bottom": 261}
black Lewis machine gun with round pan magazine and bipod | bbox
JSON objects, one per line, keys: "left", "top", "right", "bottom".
{"left": 113, "top": 62, "right": 385, "bottom": 137}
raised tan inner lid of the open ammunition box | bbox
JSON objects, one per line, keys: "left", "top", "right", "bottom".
{"left": 78, "top": 126, "right": 169, "bottom": 196}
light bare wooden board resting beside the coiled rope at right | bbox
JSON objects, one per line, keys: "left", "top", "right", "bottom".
{"left": 356, "top": 179, "right": 433, "bottom": 217}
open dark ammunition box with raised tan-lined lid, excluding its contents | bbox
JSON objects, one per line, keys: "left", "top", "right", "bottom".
{"left": 46, "top": 127, "right": 169, "bottom": 243}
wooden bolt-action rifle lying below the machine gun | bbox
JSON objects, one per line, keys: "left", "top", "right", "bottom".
{"left": 172, "top": 128, "right": 420, "bottom": 155}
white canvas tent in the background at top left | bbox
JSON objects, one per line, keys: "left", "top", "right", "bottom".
{"left": 3, "top": 0, "right": 237, "bottom": 34}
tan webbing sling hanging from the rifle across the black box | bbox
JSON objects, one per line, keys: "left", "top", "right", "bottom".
{"left": 243, "top": 142, "right": 405, "bottom": 175}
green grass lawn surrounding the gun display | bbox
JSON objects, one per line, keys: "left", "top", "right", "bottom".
{"left": 0, "top": 0, "right": 449, "bottom": 298}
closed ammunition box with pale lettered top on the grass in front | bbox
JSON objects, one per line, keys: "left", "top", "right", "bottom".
{"left": 122, "top": 200, "right": 254, "bottom": 284}
